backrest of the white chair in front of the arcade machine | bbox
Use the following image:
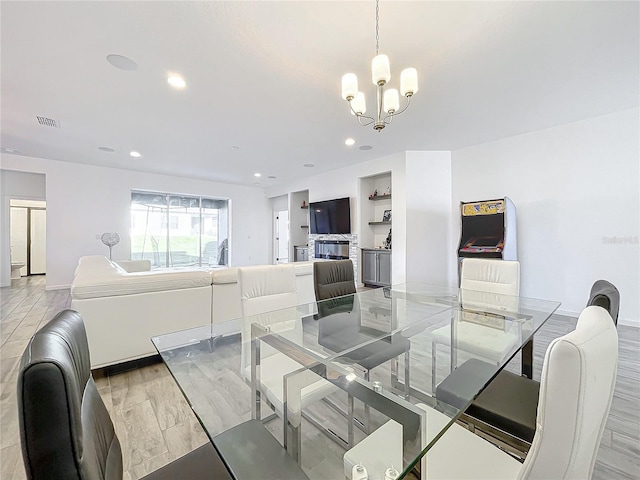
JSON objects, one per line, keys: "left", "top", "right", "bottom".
{"left": 460, "top": 258, "right": 520, "bottom": 310}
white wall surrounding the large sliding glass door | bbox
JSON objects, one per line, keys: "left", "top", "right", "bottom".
{"left": 2, "top": 154, "right": 271, "bottom": 289}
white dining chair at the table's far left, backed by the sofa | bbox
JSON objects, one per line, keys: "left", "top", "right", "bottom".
{"left": 238, "top": 264, "right": 336, "bottom": 458}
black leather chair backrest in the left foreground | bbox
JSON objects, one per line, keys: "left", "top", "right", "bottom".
{"left": 18, "top": 310, "right": 123, "bottom": 480}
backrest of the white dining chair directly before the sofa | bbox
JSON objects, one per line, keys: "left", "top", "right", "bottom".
{"left": 238, "top": 264, "right": 301, "bottom": 371}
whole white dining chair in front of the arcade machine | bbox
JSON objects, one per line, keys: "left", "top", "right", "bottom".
{"left": 431, "top": 258, "right": 520, "bottom": 393}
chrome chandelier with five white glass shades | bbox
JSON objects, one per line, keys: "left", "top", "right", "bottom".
{"left": 342, "top": 0, "right": 418, "bottom": 132}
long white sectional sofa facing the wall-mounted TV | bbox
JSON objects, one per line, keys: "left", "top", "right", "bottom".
{"left": 71, "top": 255, "right": 315, "bottom": 368}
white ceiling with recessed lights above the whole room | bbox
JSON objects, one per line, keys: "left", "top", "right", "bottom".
{"left": 0, "top": 0, "right": 640, "bottom": 187}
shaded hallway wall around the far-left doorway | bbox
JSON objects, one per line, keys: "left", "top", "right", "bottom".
{"left": 0, "top": 172, "right": 46, "bottom": 287}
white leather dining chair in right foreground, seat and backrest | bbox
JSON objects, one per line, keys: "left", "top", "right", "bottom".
{"left": 344, "top": 306, "right": 618, "bottom": 480}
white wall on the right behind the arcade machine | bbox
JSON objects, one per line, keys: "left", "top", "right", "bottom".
{"left": 452, "top": 108, "right": 640, "bottom": 326}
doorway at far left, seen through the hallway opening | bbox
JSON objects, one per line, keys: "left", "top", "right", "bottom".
{"left": 9, "top": 199, "right": 47, "bottom": 278}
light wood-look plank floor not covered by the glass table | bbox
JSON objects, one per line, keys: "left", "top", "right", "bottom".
{"left": 0, "top": 276, "right": 640, "bottom": 480}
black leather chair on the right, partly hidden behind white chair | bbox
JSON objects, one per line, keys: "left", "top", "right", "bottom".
{"left": 436, "top": 280, "right": 620, "bottom": 453}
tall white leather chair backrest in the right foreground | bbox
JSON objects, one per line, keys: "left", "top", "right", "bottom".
{"left": 518, "top": 306, "right": 618, "bottom": 479}
